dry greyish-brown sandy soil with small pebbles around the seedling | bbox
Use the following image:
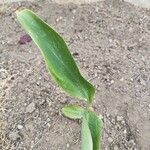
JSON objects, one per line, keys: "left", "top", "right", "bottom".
{"left": 0, "top": 0, "right": 150, "bottom": 150}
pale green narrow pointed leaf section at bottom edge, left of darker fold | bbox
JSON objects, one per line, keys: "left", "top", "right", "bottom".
{"left": 81, "top": 117, "right": 94, "bottom": 150}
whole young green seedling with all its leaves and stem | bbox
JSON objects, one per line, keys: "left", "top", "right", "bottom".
{"left": 16, "top": 9, "right": 103, "bottom": 150}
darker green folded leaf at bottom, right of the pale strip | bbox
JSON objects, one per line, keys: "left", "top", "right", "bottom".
{"left": 84, "top": 111, "right": 103, "bottom": 150}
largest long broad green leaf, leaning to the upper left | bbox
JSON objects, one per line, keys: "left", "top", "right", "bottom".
{"left": 17, "top": 9, "right": 95, "bottom": 103}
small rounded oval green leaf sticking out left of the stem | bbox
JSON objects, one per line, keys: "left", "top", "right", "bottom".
{"left": 62, "top": 105, "right": 84, "bottom": 119}
